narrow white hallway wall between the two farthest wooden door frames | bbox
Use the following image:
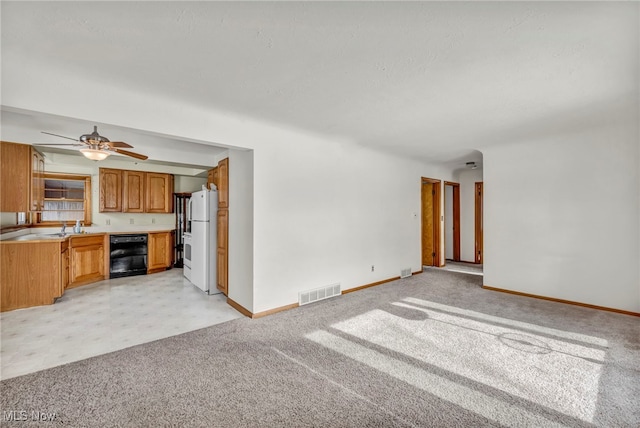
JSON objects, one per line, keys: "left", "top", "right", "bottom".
{"left": 456, "top": 168, "right": 488, "bottom": 263}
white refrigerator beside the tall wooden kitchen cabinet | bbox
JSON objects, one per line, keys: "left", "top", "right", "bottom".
{"left": 189, "top": 189, "right": 220, "bottom": 294}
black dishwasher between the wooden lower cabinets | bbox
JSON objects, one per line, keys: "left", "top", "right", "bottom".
{"left": 109, "top": 233, "right": 147, "bottom": 278}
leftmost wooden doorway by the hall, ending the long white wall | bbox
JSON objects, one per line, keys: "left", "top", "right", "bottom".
{"left": 421, "top": 177, "right": 442, "bottom": 267}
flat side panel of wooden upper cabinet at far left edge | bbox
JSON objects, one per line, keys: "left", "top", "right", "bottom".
{"left": 0, "top": 141, "right": 32, "bottom": 213}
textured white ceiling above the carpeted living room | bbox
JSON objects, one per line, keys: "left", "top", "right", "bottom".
{"left": 1, "top": 1, "right": 640, "bottom": 166}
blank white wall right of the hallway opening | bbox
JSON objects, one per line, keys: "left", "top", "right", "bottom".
{"left": 483, "top": 125, "right": 640, "bottom": 312}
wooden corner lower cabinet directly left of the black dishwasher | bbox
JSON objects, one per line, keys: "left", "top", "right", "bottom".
{"left": 68, "top": 235, "right": 106, "bottom": 288}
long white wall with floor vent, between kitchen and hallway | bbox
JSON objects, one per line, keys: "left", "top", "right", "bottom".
{"left": 254, "top": 138, "right": 450, "bottom": 311}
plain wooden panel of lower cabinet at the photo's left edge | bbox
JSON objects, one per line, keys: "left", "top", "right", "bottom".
{"left": 0, "top": 241, "right": 64, "bottom": 311}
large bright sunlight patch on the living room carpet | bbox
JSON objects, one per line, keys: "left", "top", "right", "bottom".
{"left": 318, "top": 299, "right": 606, "bottom": 422}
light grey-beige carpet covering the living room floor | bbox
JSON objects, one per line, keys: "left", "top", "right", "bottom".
{"left": 0, "top": 270, "right": 640, "bottom": 427}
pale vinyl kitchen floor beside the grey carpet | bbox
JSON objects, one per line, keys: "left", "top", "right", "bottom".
{"left": 0, "top": 269, "right": 242, "bottom": 379}
